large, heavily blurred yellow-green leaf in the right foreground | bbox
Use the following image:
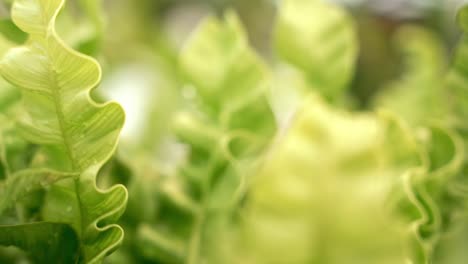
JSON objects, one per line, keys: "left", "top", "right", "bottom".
{"left": 241, "top": 96, "right": 417, "bottom": 264}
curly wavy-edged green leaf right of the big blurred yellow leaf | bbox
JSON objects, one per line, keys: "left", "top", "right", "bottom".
{"left": 399, "top": 127, "right": 466, "bottom": 263}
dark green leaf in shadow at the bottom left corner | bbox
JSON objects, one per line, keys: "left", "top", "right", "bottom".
{"left": 0, "top": 222, "right": 79, "bottom": 264}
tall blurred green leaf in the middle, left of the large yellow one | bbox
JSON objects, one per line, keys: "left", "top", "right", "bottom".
{"left": 139, "top": 12, "right": 276, "bottom": 264}
